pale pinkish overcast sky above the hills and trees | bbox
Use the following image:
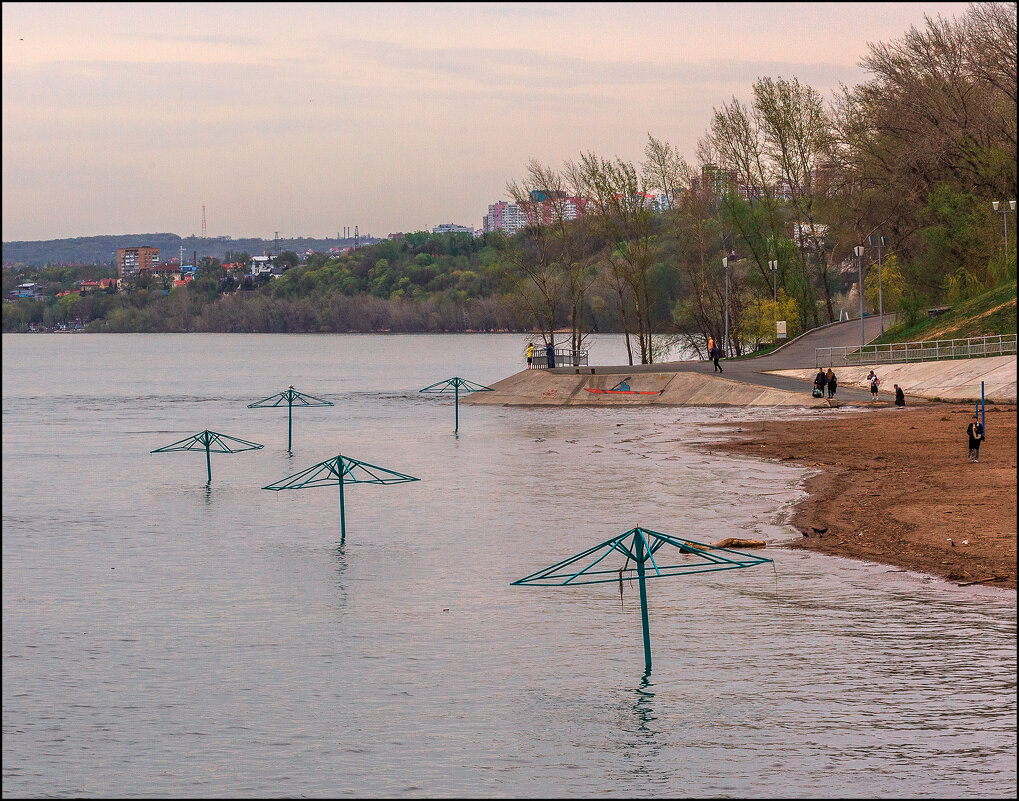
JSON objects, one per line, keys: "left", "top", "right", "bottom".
{"left": 2, "top": 3, "right": 967, "bottom": 241}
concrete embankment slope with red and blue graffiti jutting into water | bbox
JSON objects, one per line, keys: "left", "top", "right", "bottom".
{"left": 461, "top": 368, "right": 823, "bottom": 407}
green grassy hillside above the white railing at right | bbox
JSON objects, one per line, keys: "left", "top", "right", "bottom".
{"left": 874, "top": 281, "right": 1016, "bottom": 343}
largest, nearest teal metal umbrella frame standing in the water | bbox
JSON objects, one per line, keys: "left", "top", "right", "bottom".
{"left": 513, "top": 527, "right": 772, "bottom": 674}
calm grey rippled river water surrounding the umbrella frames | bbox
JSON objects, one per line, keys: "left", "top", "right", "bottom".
{"left": 3, "top": 334, "right": 1016, "bottom": 798}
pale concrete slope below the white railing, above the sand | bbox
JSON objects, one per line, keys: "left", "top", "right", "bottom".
{"left": 768, "top": 356, "right": 1016, "bottom": 404}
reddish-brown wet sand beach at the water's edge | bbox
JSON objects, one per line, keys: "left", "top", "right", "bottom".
{"left": 712, "top": 404, "right": 1016, "bottom": 589}
